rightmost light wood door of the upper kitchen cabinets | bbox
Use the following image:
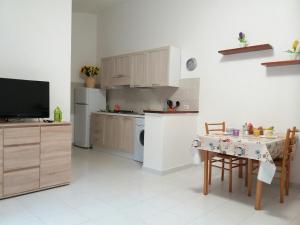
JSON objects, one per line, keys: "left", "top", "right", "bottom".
{"left": 147, "top": 49, "right": 169, "bottom": 86}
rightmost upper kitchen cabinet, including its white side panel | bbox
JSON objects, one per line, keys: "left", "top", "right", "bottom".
{"left": 146, "top": 47, "right": 181, "bottom": 87}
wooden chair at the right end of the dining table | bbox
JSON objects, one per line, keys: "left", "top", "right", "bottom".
{"left": 248, "top": 127, "right": 299, "bottom": 203}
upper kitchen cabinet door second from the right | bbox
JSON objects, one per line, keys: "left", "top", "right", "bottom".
{"left": 131, "top": 52, "right": 151, "bottom": 87}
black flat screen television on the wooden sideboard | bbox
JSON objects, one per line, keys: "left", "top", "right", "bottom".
{"left": 0, "top": 78, "right": 49, "bottom": 118}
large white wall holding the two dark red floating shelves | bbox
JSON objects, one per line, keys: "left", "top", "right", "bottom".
{"left": 100, "top": 0, "right": 300, "bottom": 184}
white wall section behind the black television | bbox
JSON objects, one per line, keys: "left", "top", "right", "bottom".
{"left": 0, "top": 0, "right": 72, "bottom": 121}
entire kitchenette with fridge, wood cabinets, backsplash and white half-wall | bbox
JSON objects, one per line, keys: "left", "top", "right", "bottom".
{"left": 75, "top": 46, "right": 199, "bottom": 174}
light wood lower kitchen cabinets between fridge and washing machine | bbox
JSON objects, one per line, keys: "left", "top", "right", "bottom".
{"left": 92, "top": 114, "right": 135, "bottom": 153}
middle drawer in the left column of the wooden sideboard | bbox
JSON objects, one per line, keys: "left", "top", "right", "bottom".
{"left": 4, "top": 144, "right": 40, "bottom": 171}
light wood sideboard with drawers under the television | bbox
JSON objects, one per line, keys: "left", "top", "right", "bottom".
{"left": 0, "top": 122, "right": 72, "bottom": 199}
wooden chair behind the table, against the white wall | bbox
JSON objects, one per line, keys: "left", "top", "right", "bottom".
{"left": 205, "top": 122, "right": 247, "bottom": 192}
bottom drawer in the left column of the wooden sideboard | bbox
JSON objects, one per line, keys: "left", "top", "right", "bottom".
{"left": 3, "top": 168, "right": 40, "bottom": 196}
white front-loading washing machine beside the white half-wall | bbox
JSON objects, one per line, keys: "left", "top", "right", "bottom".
{"left": 133, "top": 118, "right": 145, "bottom": 162}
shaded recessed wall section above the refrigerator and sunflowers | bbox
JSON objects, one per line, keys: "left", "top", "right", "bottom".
{"left": 71, "top": 13, "right": 98, "bottom": 83}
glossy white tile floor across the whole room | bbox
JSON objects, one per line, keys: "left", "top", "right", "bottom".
{"left": 0, "top": 149, "right": 300, "bottom": 225}
